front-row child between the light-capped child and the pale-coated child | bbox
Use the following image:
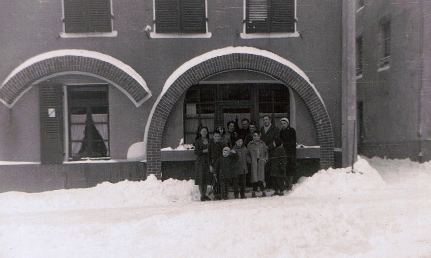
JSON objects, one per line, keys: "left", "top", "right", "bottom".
{"left": 233, "top": 137, "right": 250, "bottom": 199}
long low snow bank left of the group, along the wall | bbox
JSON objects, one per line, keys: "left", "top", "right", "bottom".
{"left": 0, "top": 175, "right": 198, "bottom": 214}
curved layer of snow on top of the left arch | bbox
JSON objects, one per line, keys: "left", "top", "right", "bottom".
{"left": 1, "top": 49, "right": 151, "bottom": 107}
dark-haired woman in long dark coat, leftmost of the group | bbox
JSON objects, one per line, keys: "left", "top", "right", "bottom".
{"left": 194, "top": 127, "right": 211, "bottom": 201}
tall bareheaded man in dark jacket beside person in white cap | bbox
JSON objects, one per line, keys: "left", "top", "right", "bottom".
{"left": 260, "top": 115, "right": 280, "bottom": 188}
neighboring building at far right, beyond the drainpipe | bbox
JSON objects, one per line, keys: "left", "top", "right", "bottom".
{"left": 356, "top": 0, "right": 431, "bottom": 161}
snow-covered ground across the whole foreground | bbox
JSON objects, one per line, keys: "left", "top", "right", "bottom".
{"left": 0, "top": 158, "right": 431, "bottom": 258}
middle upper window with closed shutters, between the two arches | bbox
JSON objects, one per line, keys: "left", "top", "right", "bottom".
{"left": 155, "top": 0, "right": 207, "bottom": 34}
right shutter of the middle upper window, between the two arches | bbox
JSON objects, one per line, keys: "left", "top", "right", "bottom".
{"left": 181, "top": 0, "right": 206, "bottom": 33}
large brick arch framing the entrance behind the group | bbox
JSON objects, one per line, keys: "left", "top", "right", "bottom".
{"left": 147, "top": 54, "right": 334, "bottom": 176}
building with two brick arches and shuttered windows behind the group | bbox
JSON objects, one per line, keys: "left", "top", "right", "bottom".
{"left": 0, "top": 0, "right": 358, "bottom": 191}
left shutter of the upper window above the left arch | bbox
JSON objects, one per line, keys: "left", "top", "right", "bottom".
{"left": 63, "top": 0, "right": 88, "bottom": 33}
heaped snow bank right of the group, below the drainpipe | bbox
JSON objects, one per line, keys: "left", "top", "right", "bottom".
{"left": 291, "top": 157, "right": 385, "bottom": 197}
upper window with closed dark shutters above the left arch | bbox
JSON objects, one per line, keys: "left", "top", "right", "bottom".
{"left": 63, "top": 0, "right": 112, "bottom": 33}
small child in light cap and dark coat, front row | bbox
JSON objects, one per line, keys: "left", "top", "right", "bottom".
{"left": 214, "top": 147, "right": 238, "bottom": 200}
